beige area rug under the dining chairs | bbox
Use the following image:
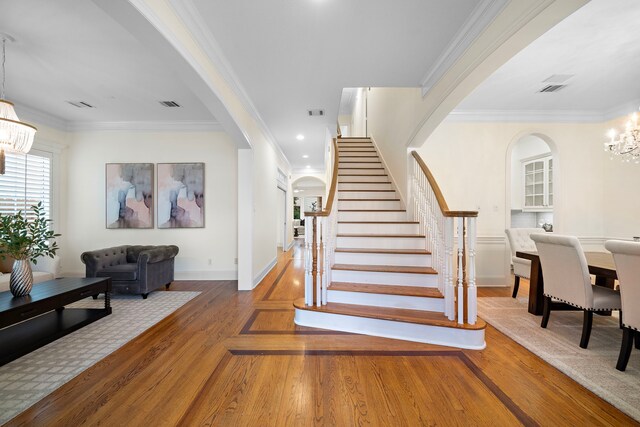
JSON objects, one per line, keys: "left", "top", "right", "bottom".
{"left": 478, "top": 298, "right": 640, "bottom": 421}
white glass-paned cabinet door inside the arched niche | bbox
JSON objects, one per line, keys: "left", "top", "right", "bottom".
{"left": 522, "top": 156, "right": 553, "bottom": 210}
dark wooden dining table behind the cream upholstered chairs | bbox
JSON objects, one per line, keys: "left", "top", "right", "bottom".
{"left": 516, "top": 251, "right": 618, "bottom": 316}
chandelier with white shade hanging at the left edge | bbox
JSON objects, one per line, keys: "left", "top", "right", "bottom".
{"left": 0, "top": 33, "right": 37, "bottom": 175}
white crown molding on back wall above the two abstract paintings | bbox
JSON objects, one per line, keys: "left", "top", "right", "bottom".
{"left": 68, "top": 120, "right": 224, "bottom": 132}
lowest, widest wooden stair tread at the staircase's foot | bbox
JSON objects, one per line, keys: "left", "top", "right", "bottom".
{"left": 293, "top": 298, "right": 487, "bottom": 330}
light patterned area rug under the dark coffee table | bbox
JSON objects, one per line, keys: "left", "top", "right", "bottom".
{"left": 0, "top": 291, "right": 200, "bottom": 424}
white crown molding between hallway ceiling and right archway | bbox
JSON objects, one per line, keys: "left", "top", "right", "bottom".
{"left": 420, "top": 0, "right": 509, "bottom": 96}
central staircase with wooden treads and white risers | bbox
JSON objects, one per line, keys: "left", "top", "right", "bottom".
{"left": 294, "top": 138, "right": 486, "bottom": 349}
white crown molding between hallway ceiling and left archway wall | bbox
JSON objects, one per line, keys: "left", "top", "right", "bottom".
{"left": 168, "top": 0, "right": 292, "bottom": 168}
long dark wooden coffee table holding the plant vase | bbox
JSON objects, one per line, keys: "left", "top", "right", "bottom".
{"left": 0, "top": 277, "right": 111, "bottom": 366}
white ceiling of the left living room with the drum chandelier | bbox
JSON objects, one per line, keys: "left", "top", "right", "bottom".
{"left": 0, "top": 0, "right": 215, "bottom": 123}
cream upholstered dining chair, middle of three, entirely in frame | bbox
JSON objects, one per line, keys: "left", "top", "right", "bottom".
{"left": 531, "top": 234, "right": 621, "bottom": 348}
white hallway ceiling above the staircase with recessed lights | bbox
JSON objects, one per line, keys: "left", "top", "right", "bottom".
{"left": 189, "top": 0, "right": 482, "bottom": 169}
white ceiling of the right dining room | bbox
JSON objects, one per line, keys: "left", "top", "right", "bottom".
{"left": 456, "top": 0, "right": 640, "bottom": 118}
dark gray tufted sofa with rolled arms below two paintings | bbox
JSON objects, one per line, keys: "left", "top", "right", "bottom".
{"left": 80, "top": 245, "right": 178, "bottom": 299}
